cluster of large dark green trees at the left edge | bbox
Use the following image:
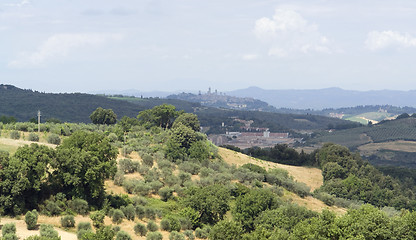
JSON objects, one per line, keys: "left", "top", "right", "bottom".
{"left": 0, "top": 132, "right": 117, "bottom": 214}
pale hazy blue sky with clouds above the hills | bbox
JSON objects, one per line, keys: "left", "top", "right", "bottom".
{"left": 0, "top": 0, "right": 416, "bottom": 92}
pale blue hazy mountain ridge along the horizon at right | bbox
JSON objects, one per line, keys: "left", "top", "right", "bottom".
{"left": 227, "top": 87, "right": 416, "bottom": 110}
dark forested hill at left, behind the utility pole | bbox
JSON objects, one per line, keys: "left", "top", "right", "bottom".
{"left": 0, "top": 84, "right": 144, "bottom": 122}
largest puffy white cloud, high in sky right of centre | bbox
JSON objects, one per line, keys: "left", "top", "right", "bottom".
{"left": 254, "top": 8, "right": 331, "bottom": 57}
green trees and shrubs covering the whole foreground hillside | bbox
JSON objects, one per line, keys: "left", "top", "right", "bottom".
{"left": 0, "top": 105, "right": 416, "bottom": 240}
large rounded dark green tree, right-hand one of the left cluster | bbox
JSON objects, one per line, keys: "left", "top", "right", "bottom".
{"left": 52, "top": 131, "right": 118, "bottom": 205}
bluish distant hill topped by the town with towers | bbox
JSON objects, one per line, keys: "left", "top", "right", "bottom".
{"left": 166, "top": 93, "right": 277, "bottom": 112}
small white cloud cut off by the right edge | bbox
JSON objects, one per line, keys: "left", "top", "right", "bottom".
{"left": 365, "top": 31, "right": 416, "bottom": 51}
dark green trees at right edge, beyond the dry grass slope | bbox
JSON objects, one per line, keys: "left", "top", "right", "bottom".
{"left": 317, "top": 144, "right": 416, "bottom": 209}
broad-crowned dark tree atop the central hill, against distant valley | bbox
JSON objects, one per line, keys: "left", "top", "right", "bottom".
{"left": 137, "top": 104, "right": 180, "bottom": 129}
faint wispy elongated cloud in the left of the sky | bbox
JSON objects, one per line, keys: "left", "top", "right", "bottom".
{"left": 8, "top": 33, "right": 123, "bottom": 68}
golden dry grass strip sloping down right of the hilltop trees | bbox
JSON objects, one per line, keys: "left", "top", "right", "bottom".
{"left": 219, "top": 148, "right": 323, "bottom": 191}
